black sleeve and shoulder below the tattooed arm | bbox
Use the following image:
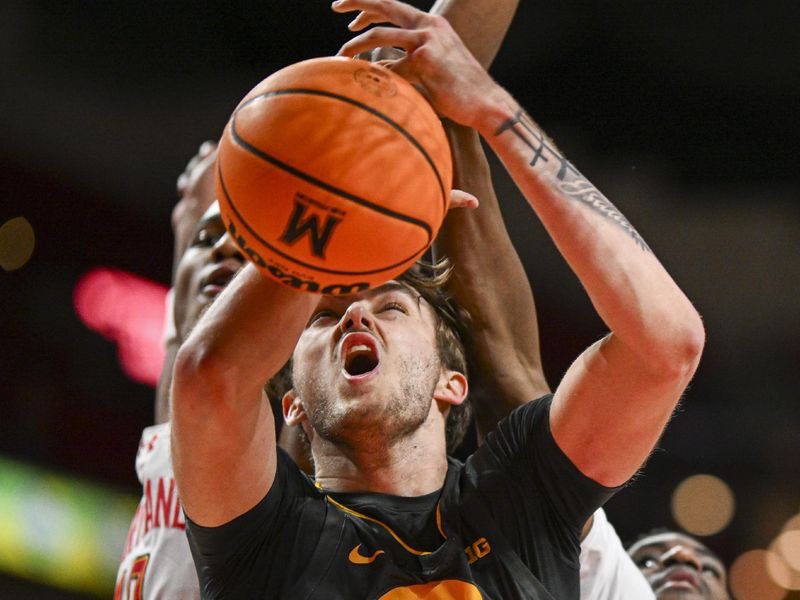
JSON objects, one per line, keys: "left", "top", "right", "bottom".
{"left": 466, "top": 395, "right": 619, "bottom": 563}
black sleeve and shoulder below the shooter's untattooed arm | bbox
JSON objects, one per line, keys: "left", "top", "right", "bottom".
{"left": 186, "top": 448, "right": 319, "bottom": 599}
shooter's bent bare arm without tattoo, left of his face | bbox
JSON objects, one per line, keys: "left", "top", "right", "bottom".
{"left": 171, "top": 268, "right": 318, "bottom": 526}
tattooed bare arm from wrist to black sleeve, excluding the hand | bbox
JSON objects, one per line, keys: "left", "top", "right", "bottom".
{"left": 480, "top": 94, "right": 705, "bottom": 486}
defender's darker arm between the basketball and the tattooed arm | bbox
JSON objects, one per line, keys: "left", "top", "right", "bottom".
{"left": 436, "top": 123, "right": 549, "bottom": 437}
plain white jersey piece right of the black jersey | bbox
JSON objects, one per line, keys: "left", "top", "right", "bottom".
{"left": 581, "top": 508, "right": 655, "bottom": 600}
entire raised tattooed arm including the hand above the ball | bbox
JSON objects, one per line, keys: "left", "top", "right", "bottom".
{"left": 333, "top": 0, "right": 704, "bottom": 486}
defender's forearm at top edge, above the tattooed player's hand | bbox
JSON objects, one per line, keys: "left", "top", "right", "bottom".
{"left": 431, "top": 0, "right": 519, "bottom": 68}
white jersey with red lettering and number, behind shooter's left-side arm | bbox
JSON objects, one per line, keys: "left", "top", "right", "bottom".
{"left": 114, "top": 423, "right": 200, "bottom": 600}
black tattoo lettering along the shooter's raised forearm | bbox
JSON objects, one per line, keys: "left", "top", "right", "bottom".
{"left": 495, "top": 109, "right": 651, "bottom": 252}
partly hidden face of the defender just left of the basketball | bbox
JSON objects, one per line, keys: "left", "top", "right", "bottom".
{"left": 174, "top": 202, "right": 244, "bottom": 340}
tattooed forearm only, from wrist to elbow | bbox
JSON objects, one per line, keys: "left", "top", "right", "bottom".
{"left": 472, "top": 95, "right": 702, "bottom": 371}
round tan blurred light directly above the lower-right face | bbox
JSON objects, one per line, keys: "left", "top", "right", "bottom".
{"left": 672, "top": 475, "right": 736, "bottom": 535}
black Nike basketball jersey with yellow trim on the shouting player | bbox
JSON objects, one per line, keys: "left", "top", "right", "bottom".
{"left": 187, "top": 398, "right": 614, "bottom": 600}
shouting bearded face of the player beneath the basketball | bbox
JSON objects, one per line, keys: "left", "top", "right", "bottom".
{"left": 293, "top": 282, "right": 445, "bottom": 445}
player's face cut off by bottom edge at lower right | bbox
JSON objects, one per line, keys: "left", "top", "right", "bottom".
{"left": 628, "top": 532, "right": 730, "bottom": 600}
